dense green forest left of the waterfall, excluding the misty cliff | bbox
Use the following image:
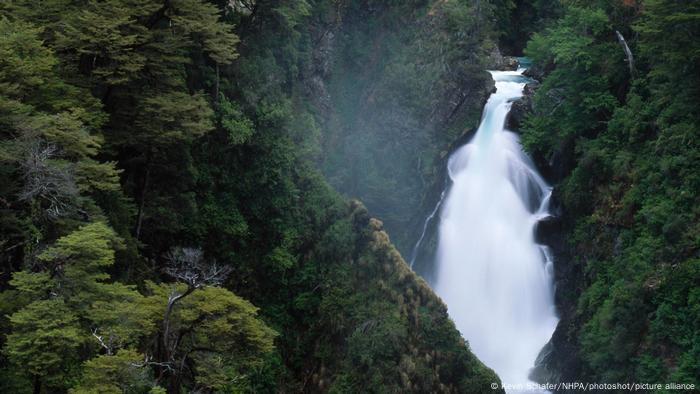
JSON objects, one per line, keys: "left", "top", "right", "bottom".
{"left": 0, "top": 0, "right": 504, "bottom": 394}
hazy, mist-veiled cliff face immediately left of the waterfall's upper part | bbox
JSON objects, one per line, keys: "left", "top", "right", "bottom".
{"left": 305, "top": 2, "right": 500, "bottom": 256}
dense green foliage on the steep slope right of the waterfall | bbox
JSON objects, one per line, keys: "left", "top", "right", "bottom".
{"left": 523, "top": 0, "right": 700, "bottom": 384}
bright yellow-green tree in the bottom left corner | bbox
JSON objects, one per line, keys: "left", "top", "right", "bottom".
{"left": 5, "top": 222, "right": 124, "bottom": 393}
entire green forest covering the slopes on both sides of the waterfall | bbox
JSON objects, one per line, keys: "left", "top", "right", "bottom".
{"left": 0, "top": 0, "right": 700, "bottom": 394}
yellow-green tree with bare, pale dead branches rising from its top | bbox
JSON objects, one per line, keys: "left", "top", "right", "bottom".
{"left": 138, "top": 248, "right": 275, "bottom": 392}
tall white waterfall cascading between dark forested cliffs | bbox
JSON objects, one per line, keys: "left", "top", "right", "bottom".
{"left": 434, "top": 69, "right": 558, "bottom": 391}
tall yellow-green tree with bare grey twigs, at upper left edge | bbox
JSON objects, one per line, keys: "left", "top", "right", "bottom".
{"left": 0, "top": 16, "right": 119, "bottom": 283}
